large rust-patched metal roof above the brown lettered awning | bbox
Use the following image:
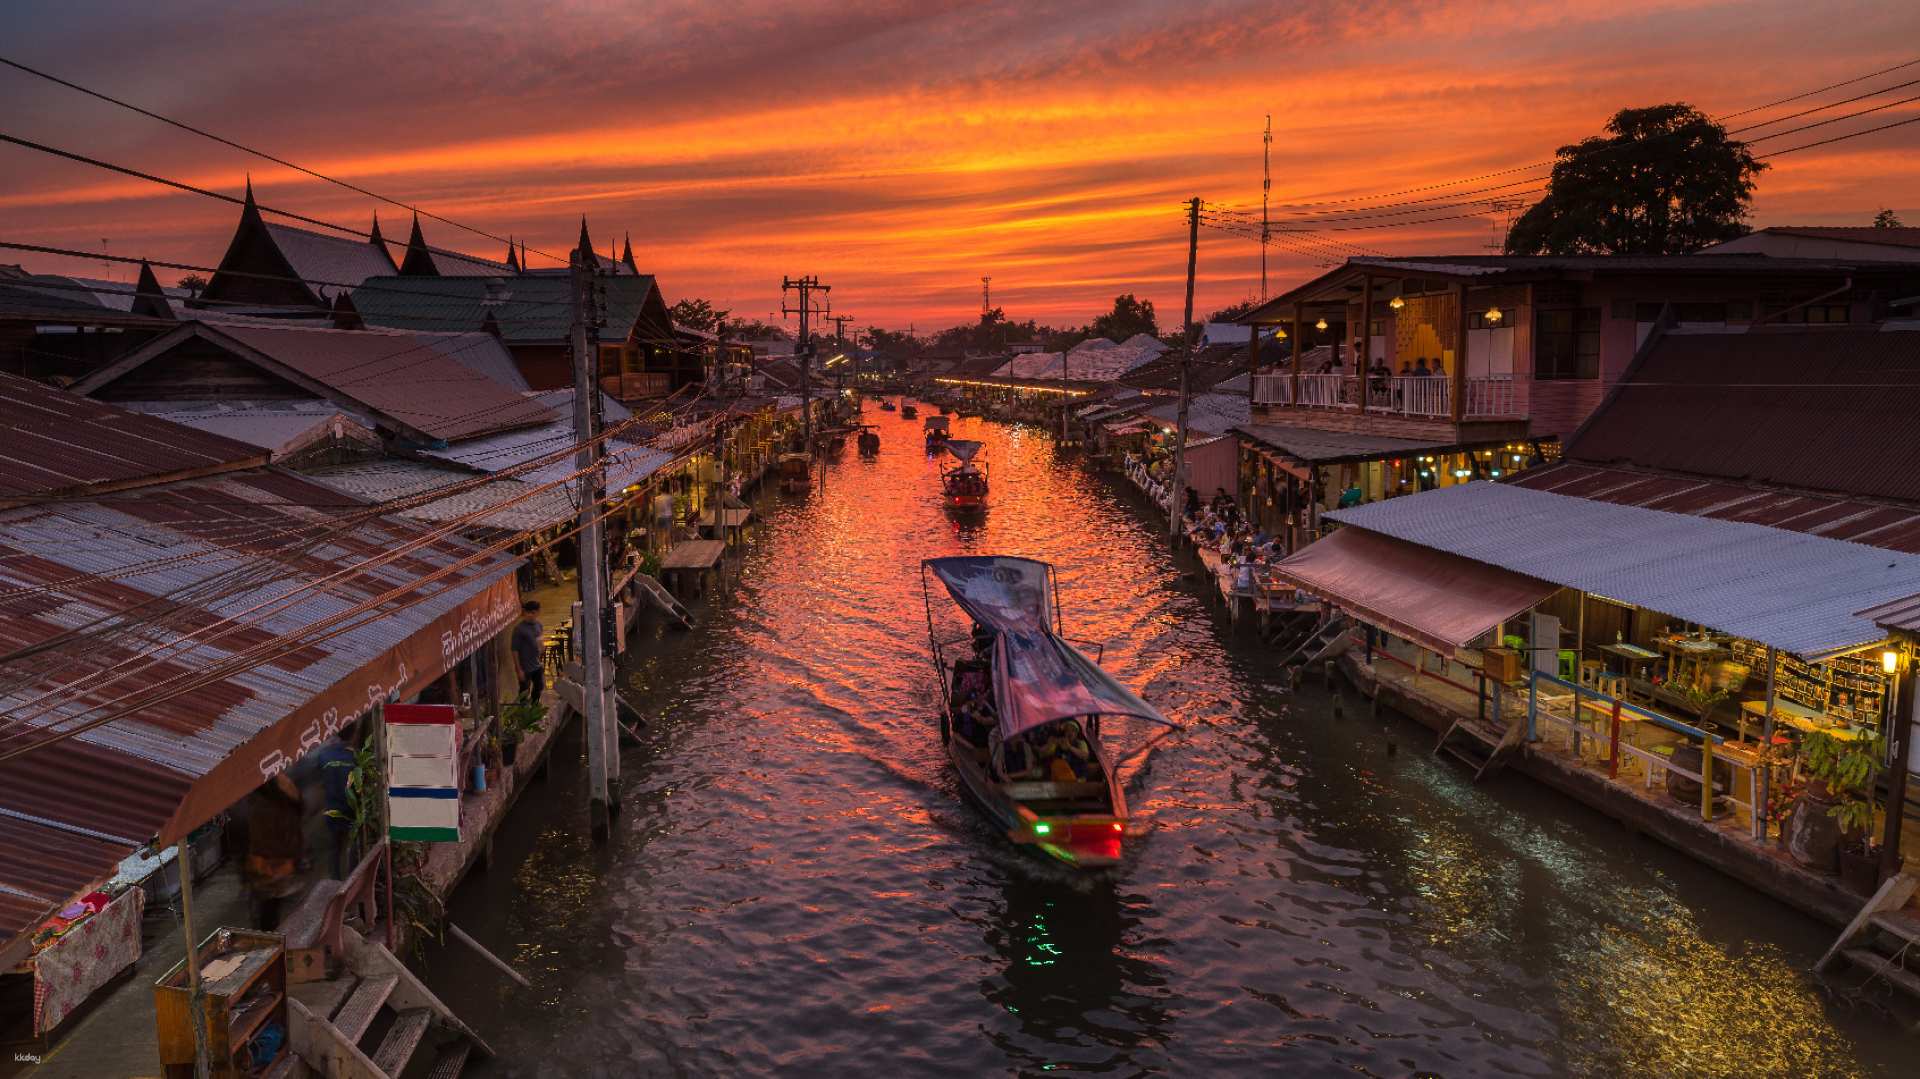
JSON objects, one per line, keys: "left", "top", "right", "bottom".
{"left": 0, "top": 462, "right": 516, "bottom": 943}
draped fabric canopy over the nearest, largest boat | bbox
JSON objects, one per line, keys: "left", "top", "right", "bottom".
{"left": 924, "top": 555, "right": 1175, "bottom": 737}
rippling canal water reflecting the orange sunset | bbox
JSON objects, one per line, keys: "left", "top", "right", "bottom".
{"left": 426, "top": 405, "right": 1910, "bottom": 1077}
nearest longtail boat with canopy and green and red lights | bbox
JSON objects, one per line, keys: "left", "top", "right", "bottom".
{"left": 920, "top": 555, "right": 1175, "bottom": 868}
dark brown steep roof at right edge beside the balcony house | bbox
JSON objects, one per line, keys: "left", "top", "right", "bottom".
{"left": 1567, "top": 326, "right": 1920, "bottom": 501}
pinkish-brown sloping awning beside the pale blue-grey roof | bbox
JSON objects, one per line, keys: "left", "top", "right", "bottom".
{"left": 1275, "top": 528, "right": 1559, "bottom": 655}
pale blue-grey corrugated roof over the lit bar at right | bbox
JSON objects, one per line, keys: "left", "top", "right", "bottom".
{"left": 1327, "top": 482, "right": 1920, "bottom": 659}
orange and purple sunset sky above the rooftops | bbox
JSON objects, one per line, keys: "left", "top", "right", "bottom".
{"left": 0, "top": 0, "right": 1920, "bottom": 330}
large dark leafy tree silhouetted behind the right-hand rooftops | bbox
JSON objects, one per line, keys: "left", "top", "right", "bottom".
{"left": 1507, "top": 102, "right": 1766, "bottom": 255}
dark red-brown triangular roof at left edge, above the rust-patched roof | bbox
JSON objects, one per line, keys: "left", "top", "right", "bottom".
{"left": 0, "top": 366, "right": 263, "bottom": 499}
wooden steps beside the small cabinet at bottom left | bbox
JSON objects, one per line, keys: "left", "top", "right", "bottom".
{"left": 288, "top": 927, "right": 493, "bottom": 1079}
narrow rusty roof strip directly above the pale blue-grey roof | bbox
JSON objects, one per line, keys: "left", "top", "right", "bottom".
{"left": 1503, "top": 461, "right": 1920, "bottom": 553}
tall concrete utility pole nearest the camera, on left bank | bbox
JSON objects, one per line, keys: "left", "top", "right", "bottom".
{"left": 570, "top": 250, "right": 616, "bottom": 843}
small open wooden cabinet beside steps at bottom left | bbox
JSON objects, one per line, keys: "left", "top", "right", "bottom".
{"left": 154, "top": 929, "right": 292, "bottom": 1079}
